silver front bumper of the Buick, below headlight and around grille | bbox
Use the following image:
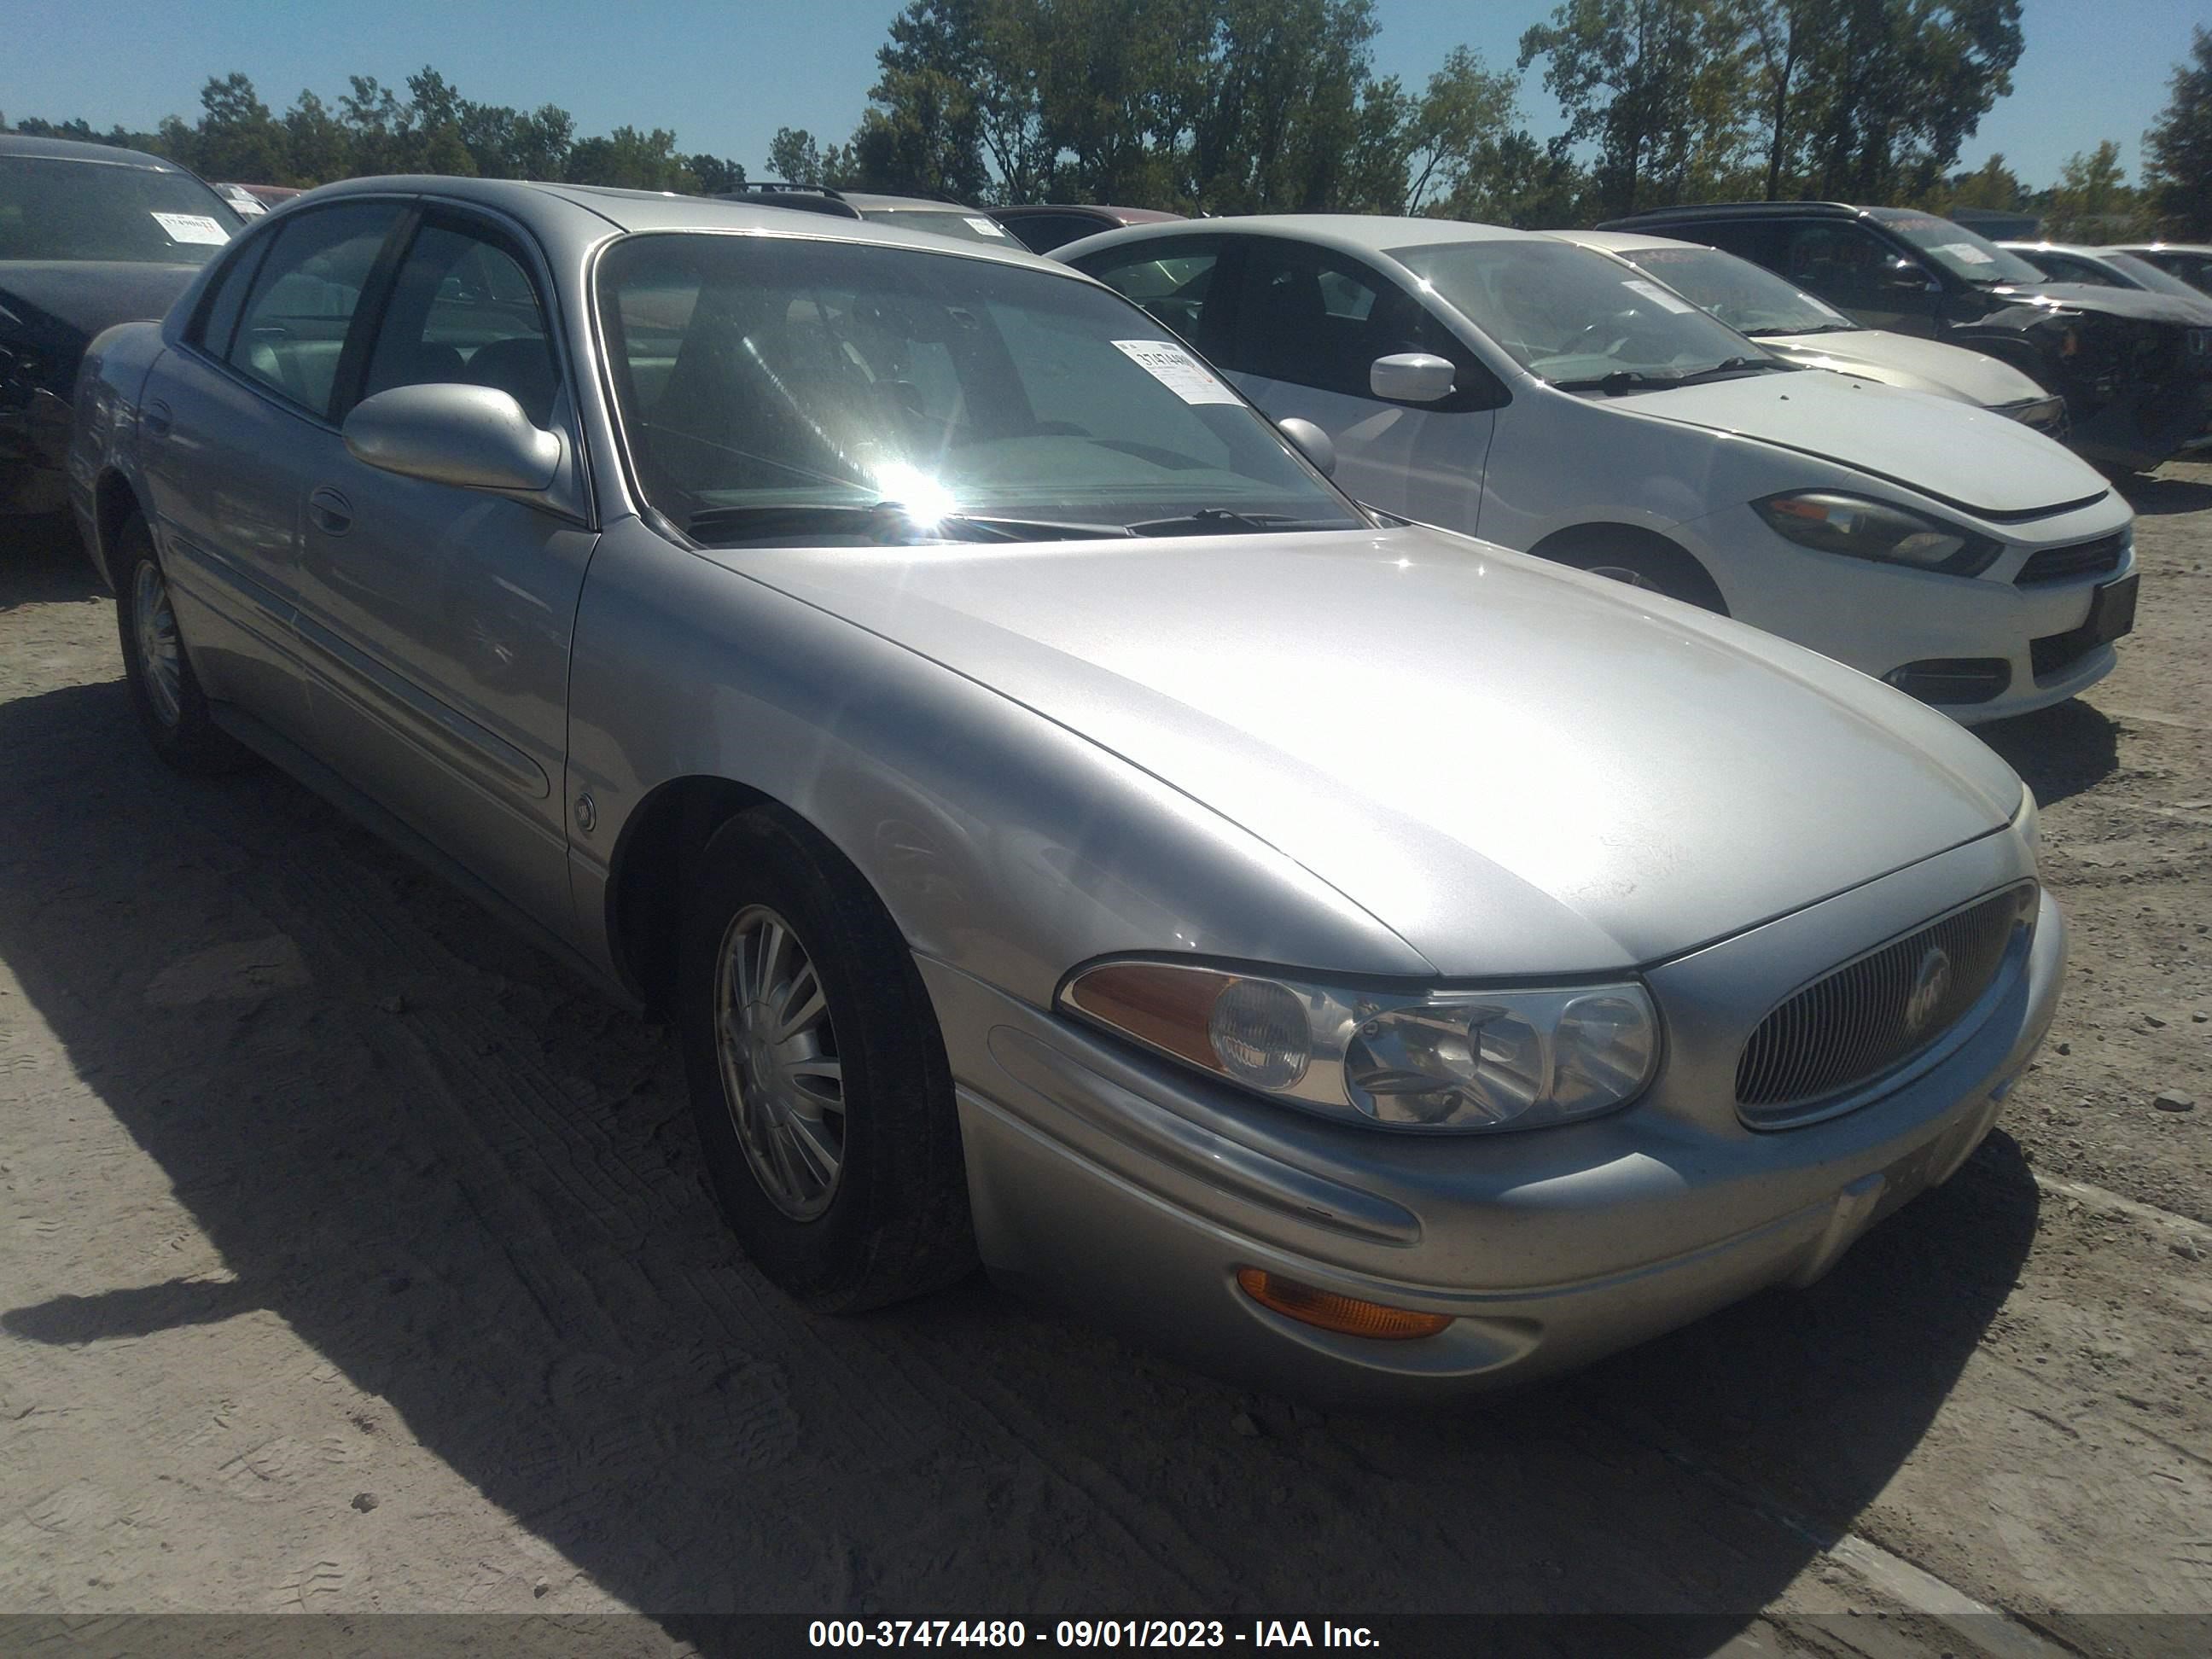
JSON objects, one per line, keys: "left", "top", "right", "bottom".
{"left": 923, "top": 834, "right": 2066, "bottom": 1398}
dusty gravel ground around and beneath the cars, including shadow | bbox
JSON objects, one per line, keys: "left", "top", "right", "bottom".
{"left": 0, "top": 467, "right": 2212, "bottom": 1659}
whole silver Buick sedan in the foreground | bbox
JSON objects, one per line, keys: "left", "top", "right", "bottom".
{"left": 71, "top": 179, "right": 2066, "bottom": 1391}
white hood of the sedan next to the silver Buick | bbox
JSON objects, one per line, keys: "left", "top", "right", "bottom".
{"left": 1613, "top": 374, "right": 2106, "bottom": 515}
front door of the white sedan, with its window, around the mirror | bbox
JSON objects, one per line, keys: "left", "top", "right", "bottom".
{"left": 1210, "top": 236, "right": 1502, "bottom": 533}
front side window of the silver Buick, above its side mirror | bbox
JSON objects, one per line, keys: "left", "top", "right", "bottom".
{"left": 360, "top": 219, "right": 560, "bottom": 427}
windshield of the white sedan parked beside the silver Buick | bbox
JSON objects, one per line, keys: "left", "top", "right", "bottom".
{"left": 1394, "top": 239, "right": 1781, "bottom": 389}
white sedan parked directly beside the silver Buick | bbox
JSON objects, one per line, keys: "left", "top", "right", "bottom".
{"left": 1053, "top": 214, "right": 2137, "bottom": 724}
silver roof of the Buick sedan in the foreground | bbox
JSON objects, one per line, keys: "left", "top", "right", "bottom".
{"left": 292, "top": 175, "right": 1066, "bottom": 274}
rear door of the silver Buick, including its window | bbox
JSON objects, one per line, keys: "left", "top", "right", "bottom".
{"left": 139, "top": 201, "right": 405, "bottom": 741}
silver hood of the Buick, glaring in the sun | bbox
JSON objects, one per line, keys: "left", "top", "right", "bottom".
{"left": 707, "top": 528, "right": 2019, "bottom": 975}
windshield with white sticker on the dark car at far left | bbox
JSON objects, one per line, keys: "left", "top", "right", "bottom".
{"left": 0, "top": 154, "right": 239, "bottom": 265}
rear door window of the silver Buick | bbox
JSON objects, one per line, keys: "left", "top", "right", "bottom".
{"left": 230, "top": 201, "right": 400, "bottom": 416}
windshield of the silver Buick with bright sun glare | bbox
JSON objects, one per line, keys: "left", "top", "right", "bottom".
{"left": 597, "top": 232, "right": 1367, "bottom": 544}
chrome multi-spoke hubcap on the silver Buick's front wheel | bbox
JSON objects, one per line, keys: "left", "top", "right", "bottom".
{"left": 714, "top": 905, "right": 845, "bottom": 1221}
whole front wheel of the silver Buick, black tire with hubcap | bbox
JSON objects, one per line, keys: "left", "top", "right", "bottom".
{"left": 677, "top": 807, "right": 975, "bottom": 1314}
